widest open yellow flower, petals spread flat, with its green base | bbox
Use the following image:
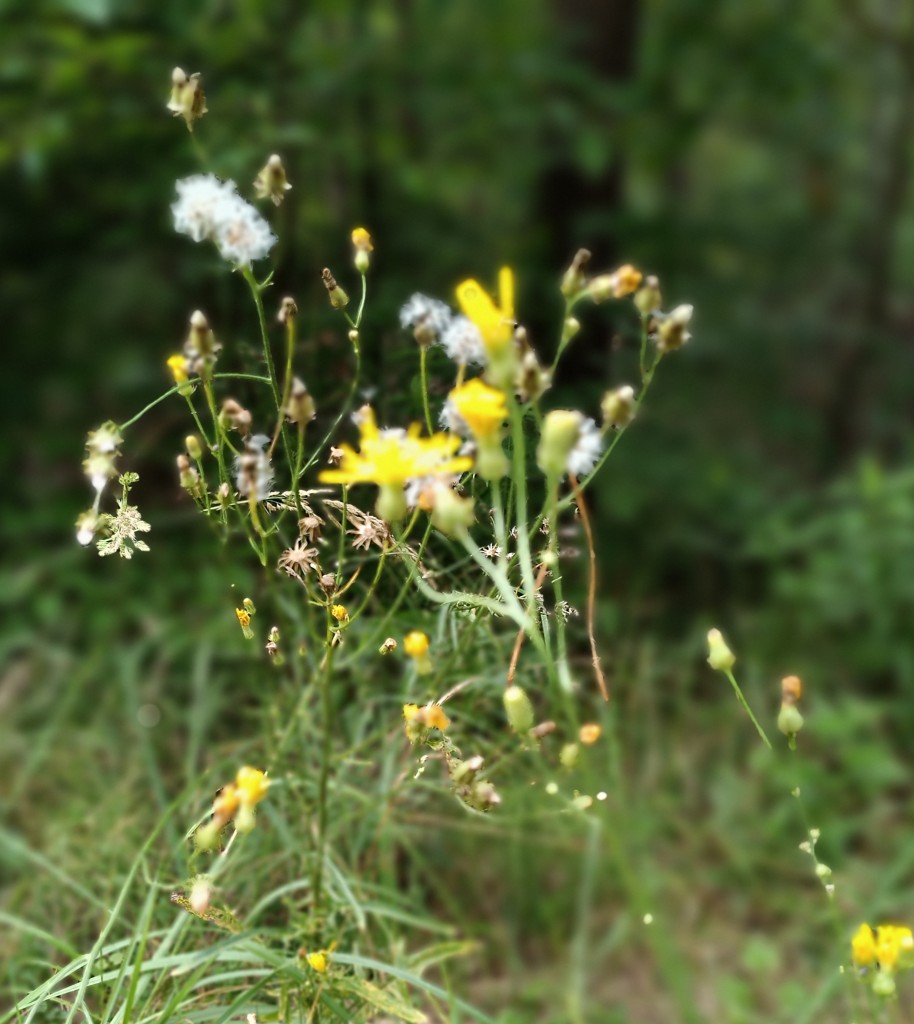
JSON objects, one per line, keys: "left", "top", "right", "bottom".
{"left": 319, "top": 407, "right": 473, "bottom": 522}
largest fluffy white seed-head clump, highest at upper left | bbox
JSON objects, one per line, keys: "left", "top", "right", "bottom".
{"left": 171, "top": 174, "right": 276, "bottom": 266}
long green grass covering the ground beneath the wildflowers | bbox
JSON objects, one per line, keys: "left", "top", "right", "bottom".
{"left": 0, "top": 542, "right": 914, "bottom": 1024}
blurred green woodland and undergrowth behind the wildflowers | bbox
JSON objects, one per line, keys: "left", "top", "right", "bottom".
{"left": 0, "top": 0, "right": 914, "bottom": 1021}
